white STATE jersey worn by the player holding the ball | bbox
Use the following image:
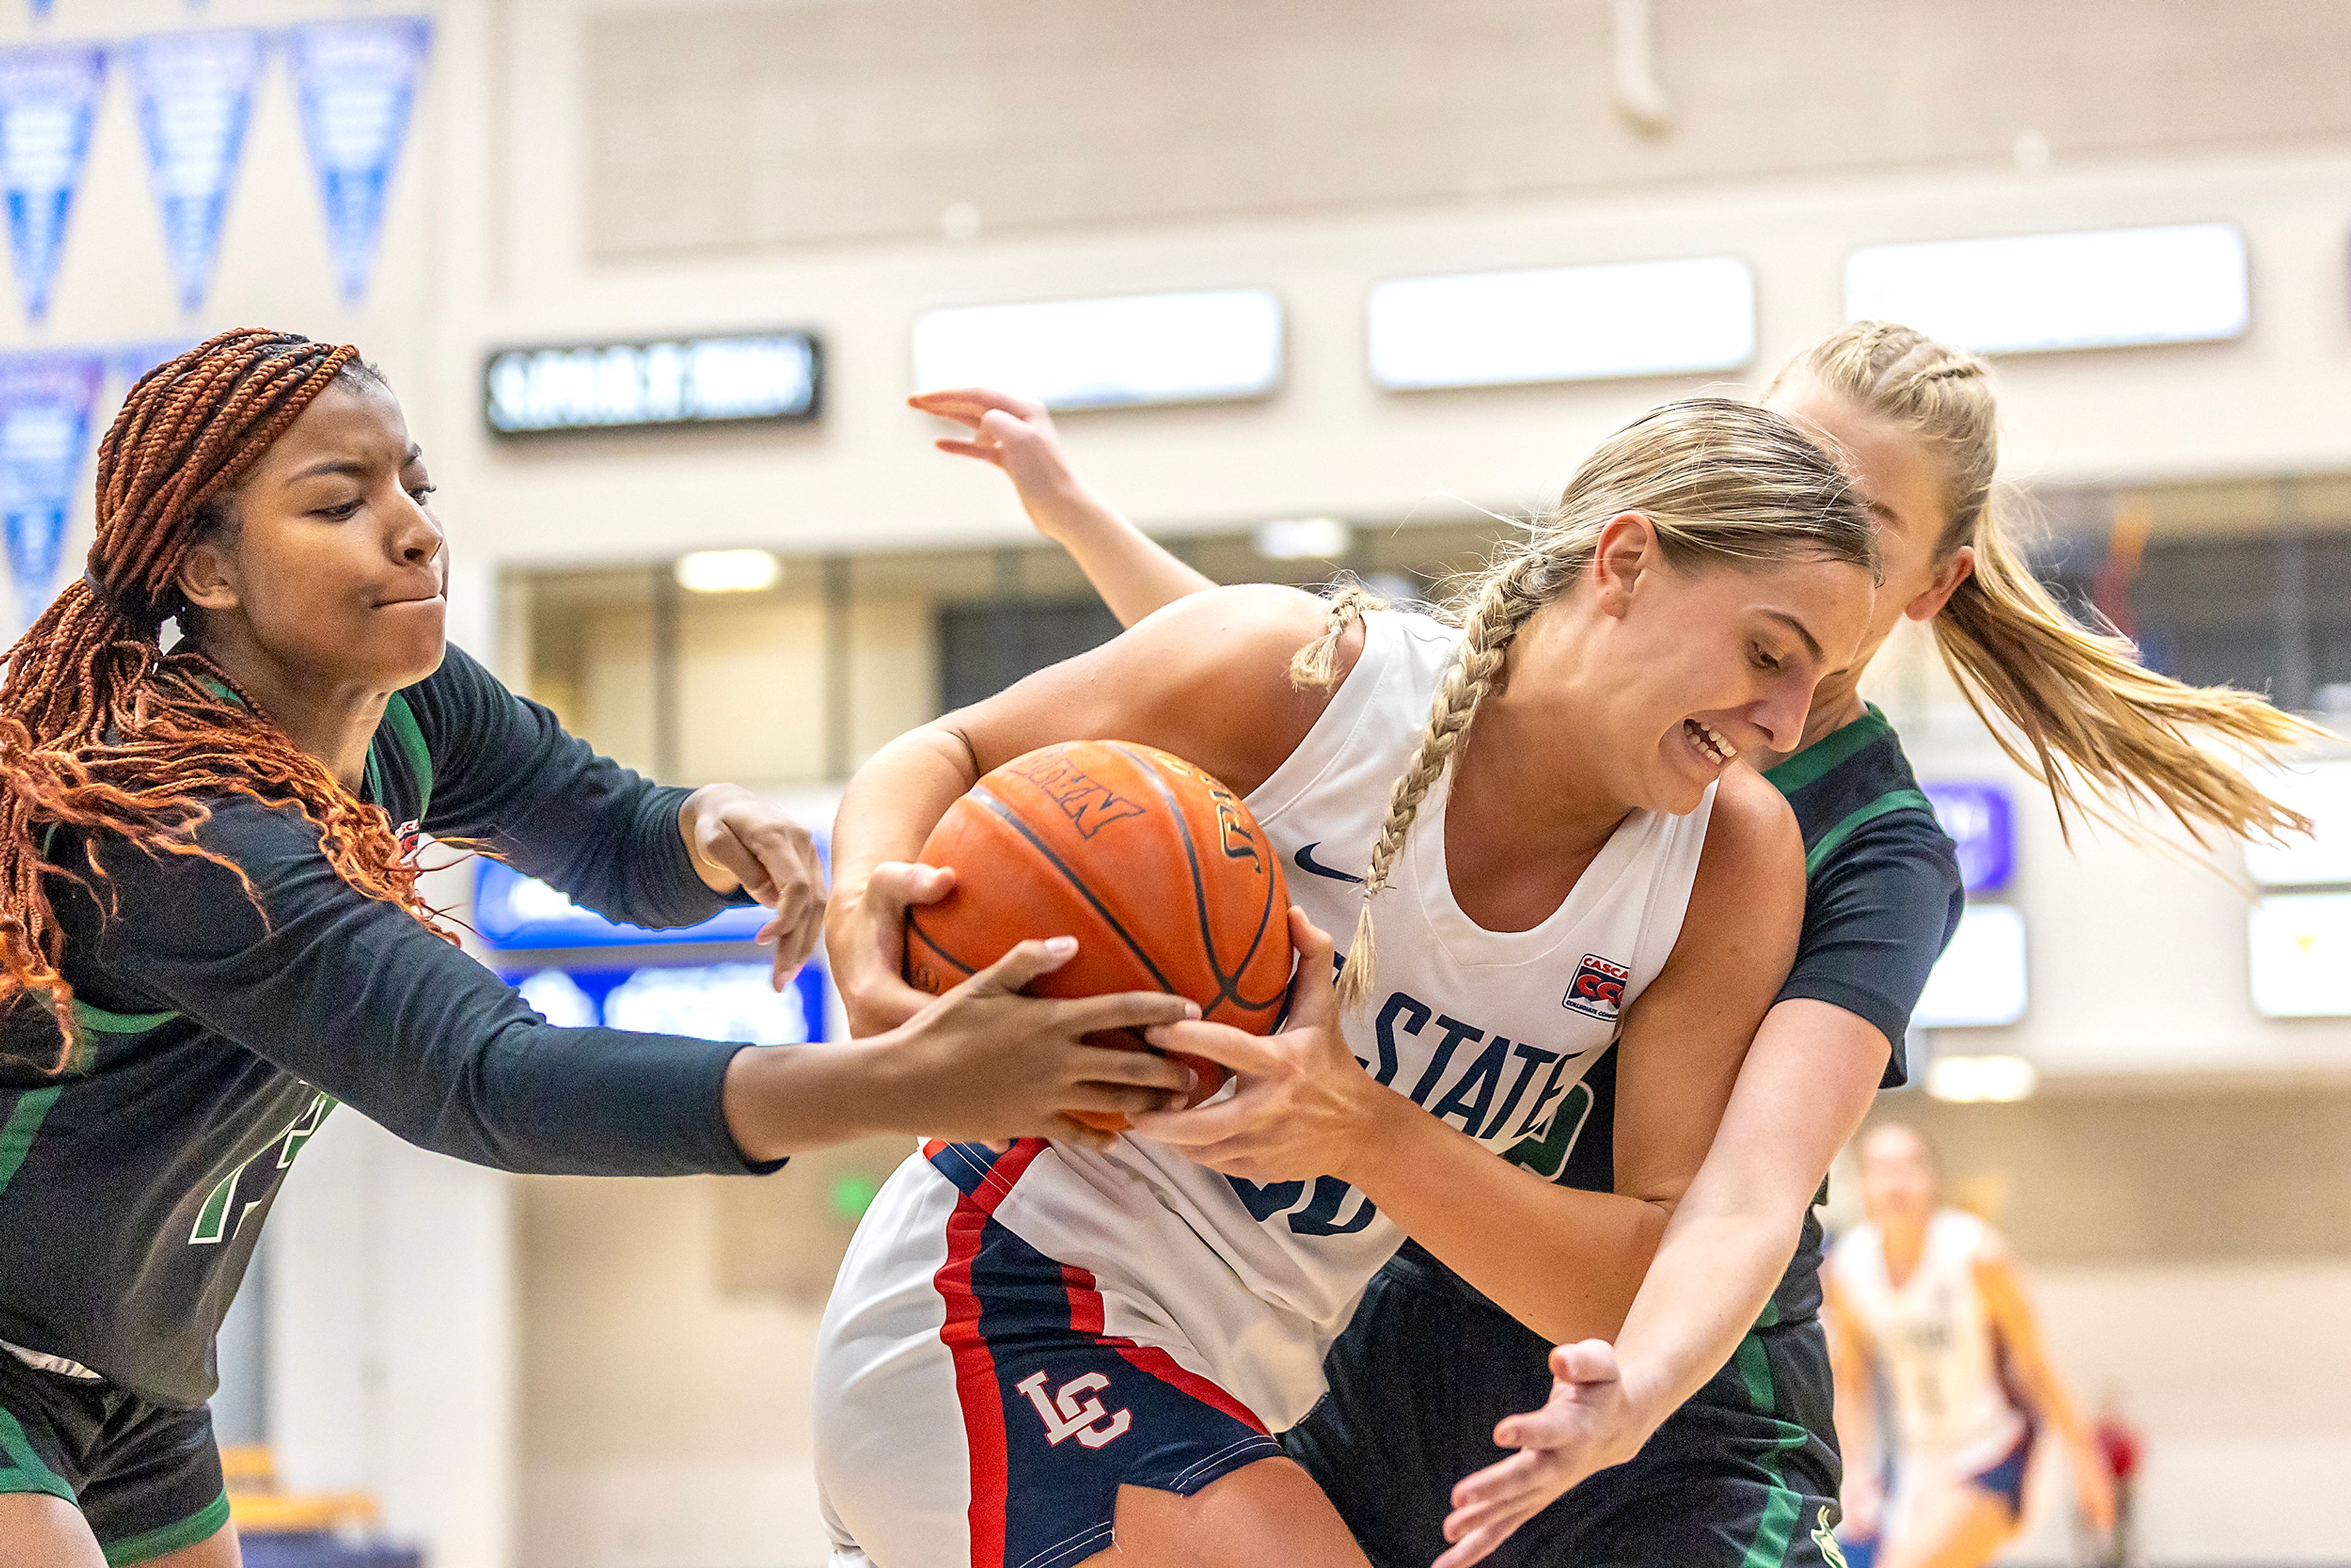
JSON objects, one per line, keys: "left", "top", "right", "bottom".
{"left": 964, "top": 611, "right": 1714, "bottom": 1431}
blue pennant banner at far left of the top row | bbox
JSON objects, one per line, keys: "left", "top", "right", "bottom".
{"left": 0, "top": 45, "right": 106, "bottom": 322}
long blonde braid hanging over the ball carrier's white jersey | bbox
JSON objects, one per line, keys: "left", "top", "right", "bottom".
{"left": 1344, "top": 548, "right": 1575, "bottom": 1011}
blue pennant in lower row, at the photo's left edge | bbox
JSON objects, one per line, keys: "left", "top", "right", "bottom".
{"left": 0, "top": 353, "right": 106, "bottom": 625}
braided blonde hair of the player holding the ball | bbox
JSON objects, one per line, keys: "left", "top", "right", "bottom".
{"left": 1325, "top": 397, "right": 1876, "bottom": 1011}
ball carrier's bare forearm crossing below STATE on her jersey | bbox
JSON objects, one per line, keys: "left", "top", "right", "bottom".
{"left": 1349, "top": 1089, "right": 1669, "bottom": 1345}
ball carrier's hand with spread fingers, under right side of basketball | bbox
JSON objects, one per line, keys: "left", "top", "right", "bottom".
{"left": 1133, "top": 910, "right": 1394, "bottom": 1182}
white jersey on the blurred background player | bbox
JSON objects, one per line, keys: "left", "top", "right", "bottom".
{"left": 1829, "top": 1209, "right": 2024, "bottom": 1469}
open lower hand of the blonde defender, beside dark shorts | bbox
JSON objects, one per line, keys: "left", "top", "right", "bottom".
{"left": 1436, "top": 1340, "right": 1653, "bottom": 1568}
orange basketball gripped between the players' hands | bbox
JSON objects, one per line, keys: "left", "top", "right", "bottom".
{"left": 905, "top": 740, "right": 1291, "bottom": 1133}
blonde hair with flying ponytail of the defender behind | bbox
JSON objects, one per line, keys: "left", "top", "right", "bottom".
{"left": 1772, "top": 322, "right": 2325, "bottom": 842}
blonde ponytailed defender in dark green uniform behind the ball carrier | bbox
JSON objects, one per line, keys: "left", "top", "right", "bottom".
{"left": 915, "top": 322, "right": 2311, "bottom": 1568}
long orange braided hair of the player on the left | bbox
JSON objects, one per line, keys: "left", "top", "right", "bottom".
{"left": 0, "top": 327, "right": 454, "bottom": 1072}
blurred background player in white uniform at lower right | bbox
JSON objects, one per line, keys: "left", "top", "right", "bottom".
{"left": 1824, "top": 1121, "right": 2113, "bottom": 1568}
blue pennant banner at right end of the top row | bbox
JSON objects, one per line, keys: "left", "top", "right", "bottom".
{"left": 287, "top": 17, "right": 433, "bottom": 303}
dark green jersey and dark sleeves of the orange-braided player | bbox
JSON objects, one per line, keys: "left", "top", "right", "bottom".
{"left": 0, "top": 649, "right": 766, "bottom": 1406}
